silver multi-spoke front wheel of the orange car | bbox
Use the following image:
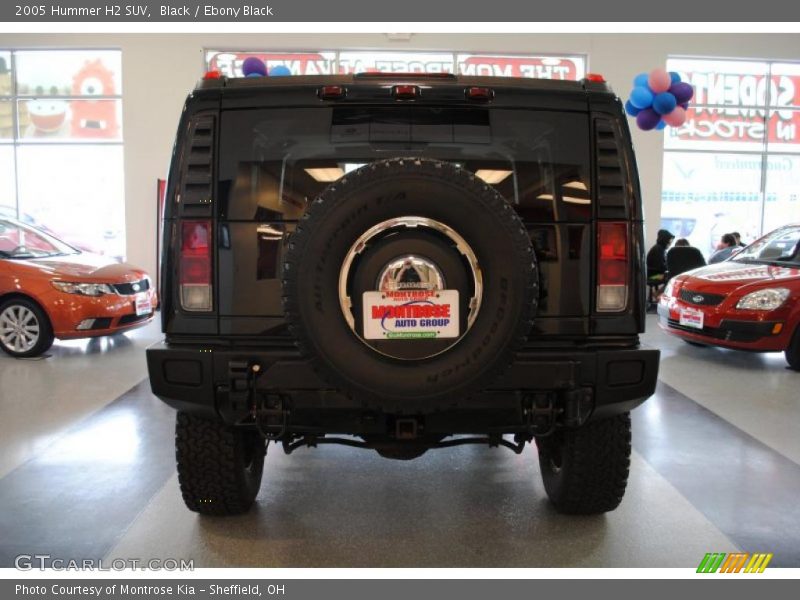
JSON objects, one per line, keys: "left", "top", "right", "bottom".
{"left": 0, "top": 298, "right": 54, "bottom": 358}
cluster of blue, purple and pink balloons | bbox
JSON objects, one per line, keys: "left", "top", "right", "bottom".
{"left": 625, "top": 69, "right": 694, "bottom": 131}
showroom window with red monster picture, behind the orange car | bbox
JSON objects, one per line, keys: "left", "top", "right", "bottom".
{"left": 0, "top": 50, "right": 125, "bottom": 260}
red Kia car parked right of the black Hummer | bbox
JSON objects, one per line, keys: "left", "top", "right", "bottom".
{"left": 658, "top": 225, "right": 800, "bottom": 370}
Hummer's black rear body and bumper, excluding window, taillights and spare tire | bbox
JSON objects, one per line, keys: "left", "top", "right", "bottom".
{"left": 153, "top": 75, "right": 658, "bottom": 435}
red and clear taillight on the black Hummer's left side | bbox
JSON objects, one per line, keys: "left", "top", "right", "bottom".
{"left": 178, "top": 220, "right": 213, "bottom": 311}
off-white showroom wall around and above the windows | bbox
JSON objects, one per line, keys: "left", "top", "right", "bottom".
{"left": 0, "top": 33, "right": 800, "bottom": 272}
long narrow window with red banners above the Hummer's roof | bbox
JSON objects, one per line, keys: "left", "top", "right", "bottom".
{"left": 205, "top": 49, "right": 586, "bottom": 81}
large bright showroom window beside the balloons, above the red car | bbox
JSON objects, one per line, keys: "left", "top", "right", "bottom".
{"left": 661, "top": 58, "right": 800, "bottom": 256}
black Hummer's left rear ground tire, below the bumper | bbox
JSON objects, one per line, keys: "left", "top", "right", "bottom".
{"left": 175, "top": 412, "right": 266, "bottom": 515}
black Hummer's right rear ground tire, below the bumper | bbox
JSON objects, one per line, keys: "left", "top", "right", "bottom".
{"left": 536, "top": 413, "right": 631, "bottom": 515}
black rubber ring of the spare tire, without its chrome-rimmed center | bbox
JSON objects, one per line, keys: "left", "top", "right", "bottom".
{"left": 283, "top": 158, "right": 538, "bottom": 410}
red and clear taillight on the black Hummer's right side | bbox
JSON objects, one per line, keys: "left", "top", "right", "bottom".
{"left": 597, "top": 221, "right": 628, "bottom": 312}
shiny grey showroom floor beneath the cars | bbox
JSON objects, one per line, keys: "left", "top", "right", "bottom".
{"left": 0, "top": 322, "right": 800, "bottom": 567}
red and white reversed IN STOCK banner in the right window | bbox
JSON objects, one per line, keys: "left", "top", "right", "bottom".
{"left": 666, "top": 65, "right": 800, "bottom": 152}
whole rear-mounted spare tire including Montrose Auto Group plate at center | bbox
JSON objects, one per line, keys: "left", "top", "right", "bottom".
{"left": 283, "top": 158, "right": 538, "bottom": 410}
